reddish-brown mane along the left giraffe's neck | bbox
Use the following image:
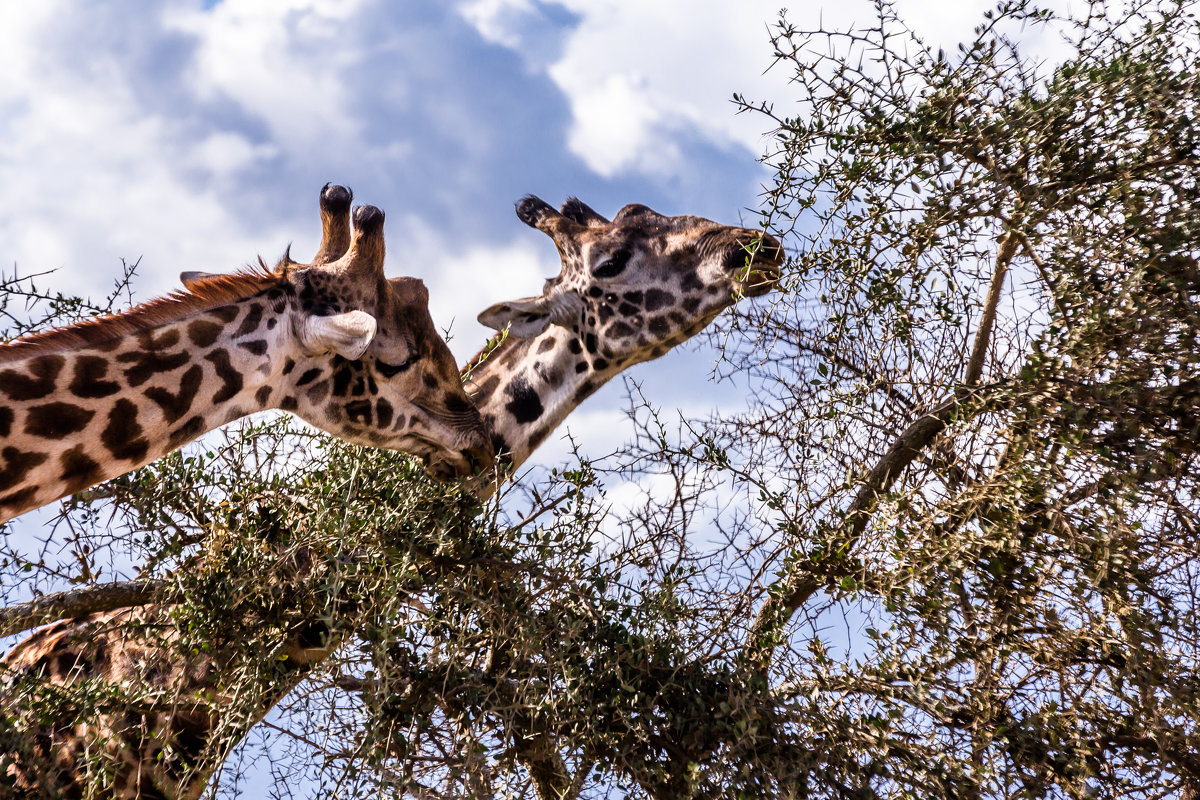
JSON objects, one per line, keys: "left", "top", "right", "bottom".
{"left": 0, "top": 265, "right": 284, "bottom": 363}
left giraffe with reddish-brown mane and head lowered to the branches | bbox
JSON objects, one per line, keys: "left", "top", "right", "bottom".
{"left": 0, "top": 186, "right": 492, "bottom": 523}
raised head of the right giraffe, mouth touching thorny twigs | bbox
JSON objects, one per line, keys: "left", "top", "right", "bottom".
{"left": 479, "top": 197, "right": 784, "bottom": 373}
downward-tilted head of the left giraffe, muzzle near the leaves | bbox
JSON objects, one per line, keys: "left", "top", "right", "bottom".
{"left": 181, "top": 186, "right": 494, "bottom": 480}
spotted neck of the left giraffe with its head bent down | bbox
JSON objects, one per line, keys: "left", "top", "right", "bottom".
{"left": 0, "top": 276, "right": 290, "bottom": 522}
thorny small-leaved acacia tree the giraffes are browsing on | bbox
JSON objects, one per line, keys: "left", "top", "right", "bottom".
{"left": 5, "top": 0, "right": 1200, "bottom": 799}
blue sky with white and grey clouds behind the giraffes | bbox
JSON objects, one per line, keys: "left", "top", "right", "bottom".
{"left": 0, "top": 0, "right": 1041, "bottom": 482}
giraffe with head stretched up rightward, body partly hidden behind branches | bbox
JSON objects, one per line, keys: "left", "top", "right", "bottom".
{"left": 0, "top": 197, "right": 782, "bottom": 800}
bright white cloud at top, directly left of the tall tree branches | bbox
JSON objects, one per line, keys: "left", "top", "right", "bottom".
{"left": 460, "top": 0, "right": 1084, "bottom": 178}
